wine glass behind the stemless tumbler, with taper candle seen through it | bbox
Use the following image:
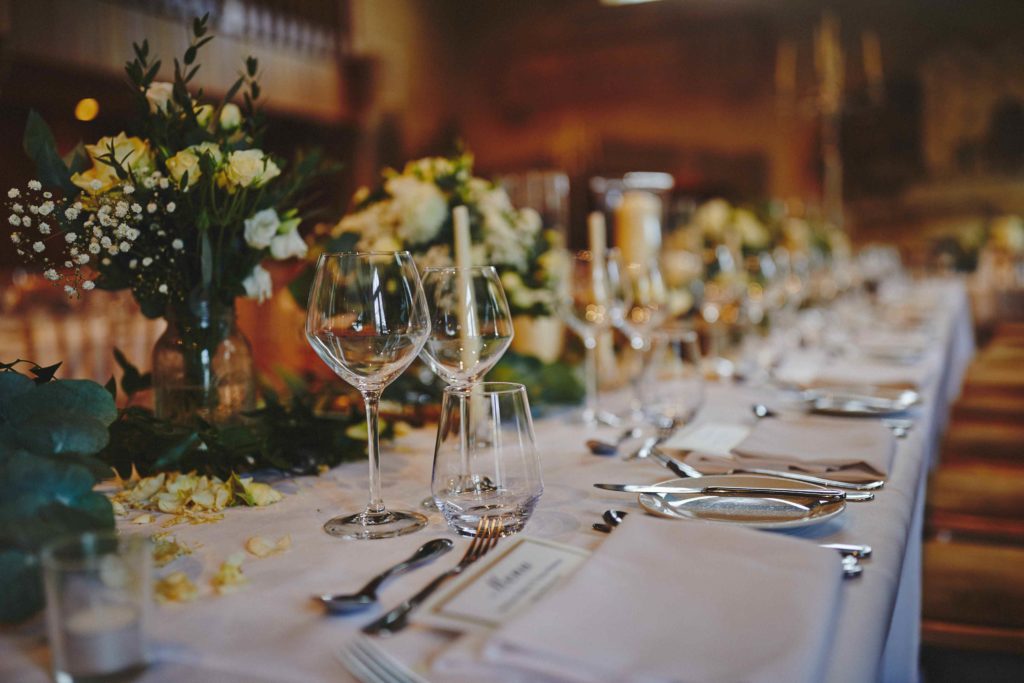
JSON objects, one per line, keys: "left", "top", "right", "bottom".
{"left": 420, "top": 265, "right": 513, "bottom": 508}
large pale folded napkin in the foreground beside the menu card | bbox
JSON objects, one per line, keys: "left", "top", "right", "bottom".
{"left": 433, "top": 514, "right": 842, "bottom": 683}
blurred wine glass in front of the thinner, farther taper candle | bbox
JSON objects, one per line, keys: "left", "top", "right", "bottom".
{"left": 559, "top": 251, "right": 625, "bottom": 424}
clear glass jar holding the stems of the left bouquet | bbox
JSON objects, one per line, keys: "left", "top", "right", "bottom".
{"left": 153, "top": 303, "right": 256, "bottom": 424}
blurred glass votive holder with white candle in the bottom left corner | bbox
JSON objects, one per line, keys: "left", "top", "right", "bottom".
{"left": 42, "top": 531, "right": 153, "bottom": 683}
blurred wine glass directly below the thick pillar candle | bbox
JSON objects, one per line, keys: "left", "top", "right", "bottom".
{"left": 614, "top": 254, "right": 668, "bottom": 420}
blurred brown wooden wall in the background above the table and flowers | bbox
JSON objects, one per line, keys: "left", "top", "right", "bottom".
{"left": 0, "top": 0, "right": 1024, "bottom": 259}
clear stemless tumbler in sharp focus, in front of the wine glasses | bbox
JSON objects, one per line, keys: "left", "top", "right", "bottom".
{"left": 431, "top": 382, "right": 544, "bottom": 536}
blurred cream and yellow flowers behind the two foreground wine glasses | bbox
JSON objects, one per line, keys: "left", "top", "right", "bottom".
{"left": 332, "top": 154, "right": 562, "bottom": 315}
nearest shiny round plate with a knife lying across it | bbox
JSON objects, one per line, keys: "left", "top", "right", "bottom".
{"left": 639, "top": 474, "right": 846, "bottom": 529}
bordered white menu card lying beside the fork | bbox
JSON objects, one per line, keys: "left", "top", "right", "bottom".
{"left": 413, "top": 537, "right": 590, "bottom": 633}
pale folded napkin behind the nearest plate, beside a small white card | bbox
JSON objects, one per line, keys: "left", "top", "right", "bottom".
{"left": 732, "top": 415, "right": 896, "bottom": 478}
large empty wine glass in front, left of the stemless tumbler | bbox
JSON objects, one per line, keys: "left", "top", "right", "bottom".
{"left": 306, "top": 252, "right": 430, "bottom": 539}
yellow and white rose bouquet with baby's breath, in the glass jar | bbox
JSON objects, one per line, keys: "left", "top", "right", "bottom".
{"left": 7, "top": 17, "right": 321, "bottom": 317}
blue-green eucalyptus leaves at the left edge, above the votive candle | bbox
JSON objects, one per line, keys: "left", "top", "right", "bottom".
{"left": 0, "top": 360, "right": 117, "bottom": 623}
